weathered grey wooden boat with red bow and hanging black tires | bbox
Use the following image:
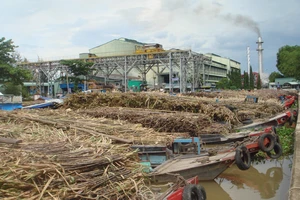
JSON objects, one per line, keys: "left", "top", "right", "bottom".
{"left": 149, "top": 127, "right": 282, "bottom": 183}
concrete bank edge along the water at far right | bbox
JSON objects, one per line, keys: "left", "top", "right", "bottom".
{"left": 289, "top": 93, "right": 300, "bottom": 200}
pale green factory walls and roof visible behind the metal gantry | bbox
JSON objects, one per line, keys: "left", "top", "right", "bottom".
{"left": 79, "top": 38, "right": 240, "bottom": 88}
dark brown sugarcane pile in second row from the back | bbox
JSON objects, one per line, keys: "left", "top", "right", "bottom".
{"left": 78, "top": 107, "right": 229, "bottom": 137}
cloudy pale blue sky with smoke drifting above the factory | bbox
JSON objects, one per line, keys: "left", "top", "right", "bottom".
{"left": 0, "top": 0, "right": 300, "bottom": 74}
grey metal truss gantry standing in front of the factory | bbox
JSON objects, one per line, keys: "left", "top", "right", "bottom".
{"left": 19, "top": 50, "right": 211, "bottom": 94}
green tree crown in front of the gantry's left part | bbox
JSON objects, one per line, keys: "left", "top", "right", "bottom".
{"left": 60, "top": 60, "right": 94, "bottom": 76}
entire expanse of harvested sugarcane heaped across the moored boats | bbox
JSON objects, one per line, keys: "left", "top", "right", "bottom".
{"left": 0, "top": 92, "right": 296, "bottom": 199}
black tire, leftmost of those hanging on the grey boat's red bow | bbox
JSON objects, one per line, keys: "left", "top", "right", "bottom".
{"left": 235, "top": 145, "right": 251, "bottom": 170}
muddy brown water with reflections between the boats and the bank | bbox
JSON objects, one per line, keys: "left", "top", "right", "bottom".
{"left": 200, "top": 156, "right": 292, "bottom": 200}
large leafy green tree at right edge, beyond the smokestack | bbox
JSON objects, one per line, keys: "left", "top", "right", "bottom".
{"left": 276, "top": 45, "right": 300, "bottom": 80}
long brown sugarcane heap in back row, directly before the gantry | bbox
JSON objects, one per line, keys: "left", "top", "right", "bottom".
{"left": 64, "top": 93, "right": 236, "bottom": 123}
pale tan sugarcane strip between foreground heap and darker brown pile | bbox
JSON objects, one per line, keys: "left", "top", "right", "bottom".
{"left": 2, "top": 109, "right": 189, "bottom": 145}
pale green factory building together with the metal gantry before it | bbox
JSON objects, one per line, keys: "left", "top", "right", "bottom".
{"left": 20, "top": 38, "right": 240, "bottom": 96}
